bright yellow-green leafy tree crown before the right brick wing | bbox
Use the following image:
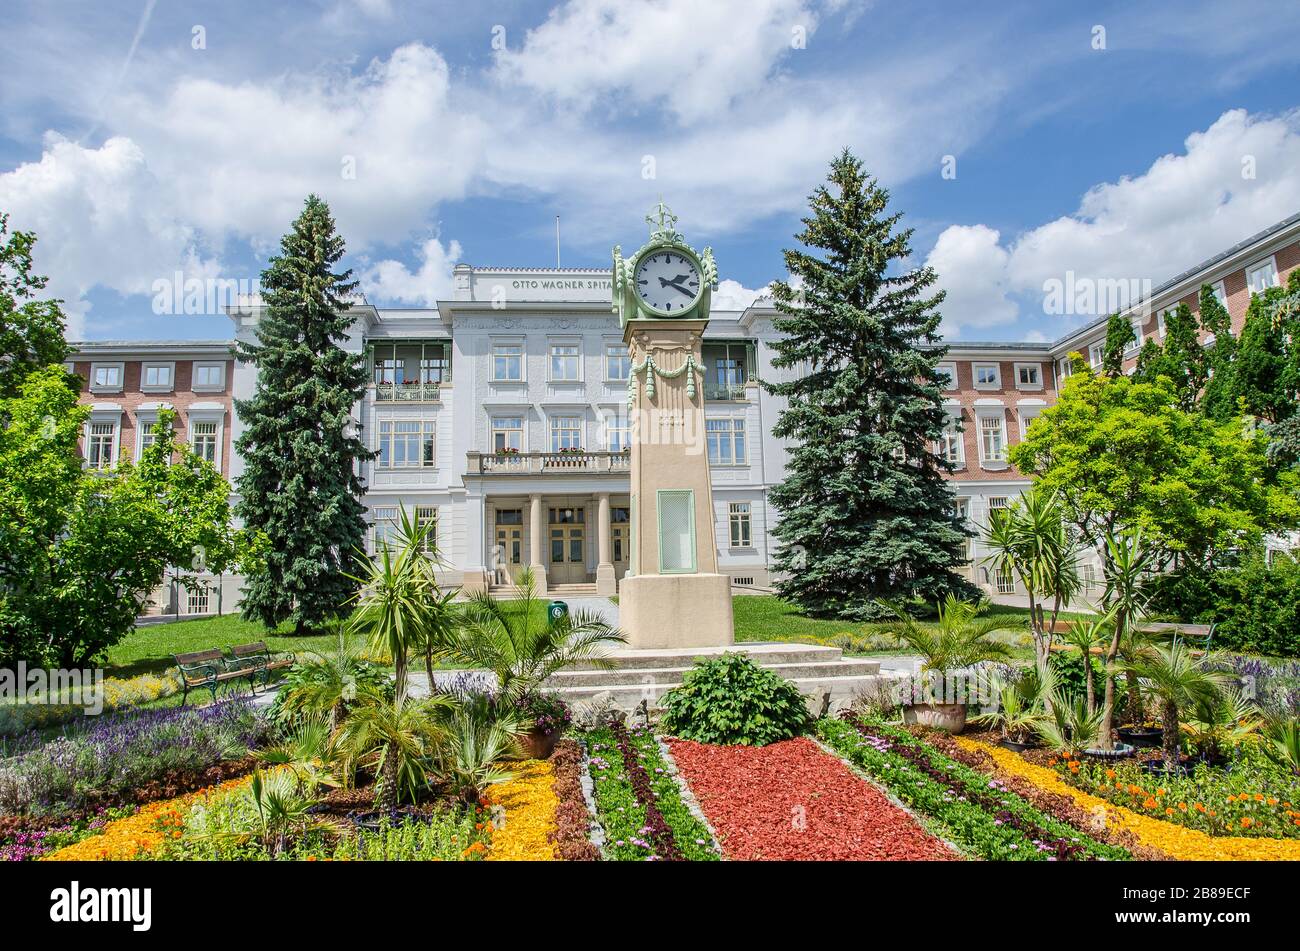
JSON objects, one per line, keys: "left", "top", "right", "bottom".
{"left": 1010, "top": 373, "right": 1300, "bottom": 564}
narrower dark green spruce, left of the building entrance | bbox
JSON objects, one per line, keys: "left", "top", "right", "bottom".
{"left": 235, "top": 195, "right": 371, "bottom": 633}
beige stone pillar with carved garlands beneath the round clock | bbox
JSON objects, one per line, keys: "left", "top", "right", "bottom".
{"left": 619, "top": 318, "right": 735, "bottom": 650}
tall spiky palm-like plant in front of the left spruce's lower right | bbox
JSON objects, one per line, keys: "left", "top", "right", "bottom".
{"left": 348, "top": 507, "right": 441, "bottom": 700}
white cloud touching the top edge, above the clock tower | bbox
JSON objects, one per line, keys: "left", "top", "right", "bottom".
{"left": 497, "top": 0, "right": 818, "bottom": 121}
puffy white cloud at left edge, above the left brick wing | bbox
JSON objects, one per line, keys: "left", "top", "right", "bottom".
{"left": 0, "top": 133, "right": 217, "bottom": 339}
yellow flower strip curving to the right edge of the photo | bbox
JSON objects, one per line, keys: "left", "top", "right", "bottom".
{"left": 954, "top": 737, "right": 1300, "bottom": 861}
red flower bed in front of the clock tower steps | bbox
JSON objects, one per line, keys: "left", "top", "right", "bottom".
{"left": 668, "top": 738, "right": 957, "bottom": 861}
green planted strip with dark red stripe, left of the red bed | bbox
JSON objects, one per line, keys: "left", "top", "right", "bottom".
{"left": 588, "top": 722, "right": 718, "bottom": 861}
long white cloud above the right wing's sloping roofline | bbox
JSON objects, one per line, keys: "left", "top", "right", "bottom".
{"left": 927, "top": 109, "right": 1300, "bottom": 338}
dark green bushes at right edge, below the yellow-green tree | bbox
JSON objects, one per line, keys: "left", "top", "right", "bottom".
{"left": 1152, "top": 553, "right": 1300, "bottom": 657}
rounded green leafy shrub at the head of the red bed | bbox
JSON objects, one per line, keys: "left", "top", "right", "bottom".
{"left": 663, "top": 653, "right": 813, "bottom": 746}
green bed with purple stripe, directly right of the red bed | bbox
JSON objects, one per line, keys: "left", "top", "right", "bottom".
{"left": 818, "top": 716, "right": 1130, "bottom": 861}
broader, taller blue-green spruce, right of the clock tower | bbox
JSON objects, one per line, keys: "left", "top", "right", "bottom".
{"left": 766, "top": 151, "right": 979, "bottom": 618}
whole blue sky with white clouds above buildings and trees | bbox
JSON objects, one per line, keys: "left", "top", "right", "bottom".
{"left": 0, "top": 0, "right": 1300, "bottom": 339}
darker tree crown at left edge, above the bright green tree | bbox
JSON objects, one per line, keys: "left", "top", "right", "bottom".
{"left": 0, "top": 212, "right": 68, "bottom": 399}
